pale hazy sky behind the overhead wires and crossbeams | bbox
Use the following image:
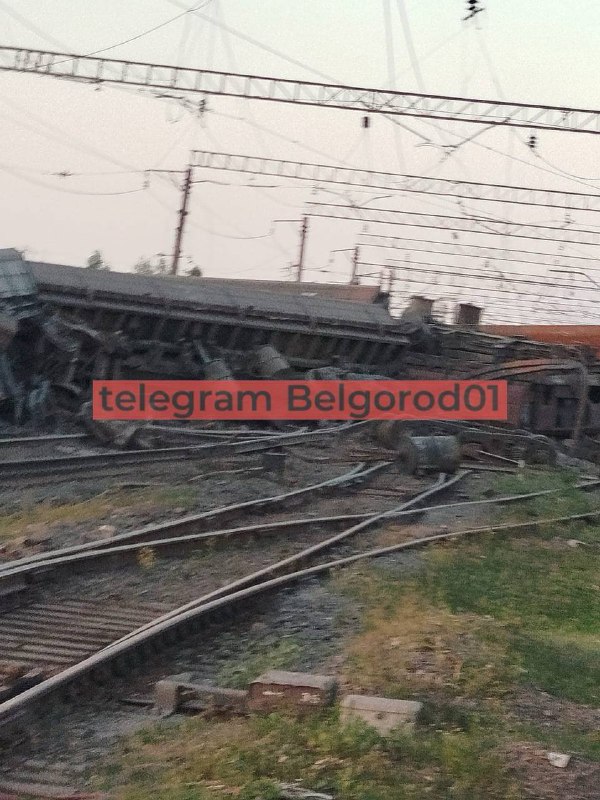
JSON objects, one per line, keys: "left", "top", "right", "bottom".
{"left": 0, "top": 0, "right": 600, "bottom": 321}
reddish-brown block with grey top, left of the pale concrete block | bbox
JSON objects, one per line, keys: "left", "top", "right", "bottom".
{"left": 248, "top": 670, "right": 337, "bottom": 713}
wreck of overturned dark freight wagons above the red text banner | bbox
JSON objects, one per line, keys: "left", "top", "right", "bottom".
{"left": 0, "top": 250, "right": 600, "bottom": 438}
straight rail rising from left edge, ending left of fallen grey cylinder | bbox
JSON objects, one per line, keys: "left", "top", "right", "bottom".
{"left": 0, "top": 461, "right": 392, "bottom": 576}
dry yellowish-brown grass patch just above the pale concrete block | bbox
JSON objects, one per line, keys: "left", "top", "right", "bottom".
{"left": 336, "top": 567, "right": 519, "bottom": 705}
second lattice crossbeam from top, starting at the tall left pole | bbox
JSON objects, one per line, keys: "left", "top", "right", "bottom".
{"left": 193, "top": 150, "right": 600, "bottom": 211}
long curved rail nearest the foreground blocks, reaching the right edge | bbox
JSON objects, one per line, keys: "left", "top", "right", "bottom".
{"left": 0, "top": 482, "right": 600, "bottom": 726}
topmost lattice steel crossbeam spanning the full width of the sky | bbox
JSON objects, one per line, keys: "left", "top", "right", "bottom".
{"left": 0, "top": 47, "right": 600, "bottom": 134}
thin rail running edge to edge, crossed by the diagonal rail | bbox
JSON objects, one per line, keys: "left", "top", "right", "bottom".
{"left": 0, "top": 480, "right": 600, "bottom": 583}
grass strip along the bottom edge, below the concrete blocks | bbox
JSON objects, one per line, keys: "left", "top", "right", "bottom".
{"left": 103, "top": 710, "right": 521, "bottom": 800}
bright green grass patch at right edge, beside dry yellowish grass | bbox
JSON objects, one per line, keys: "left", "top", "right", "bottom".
{"left": 422, "top": 527, "right": 600, "bottom": 705}
